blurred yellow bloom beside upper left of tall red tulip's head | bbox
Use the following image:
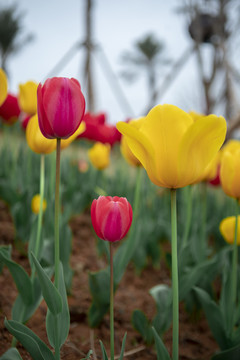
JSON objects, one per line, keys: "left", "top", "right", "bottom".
{"left": 18, "top": 81, "right": 38, "bottom": 115}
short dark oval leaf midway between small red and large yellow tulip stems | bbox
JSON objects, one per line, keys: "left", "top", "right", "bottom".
{"left": 132, "top": 310, "right": 153, "bottom": 344}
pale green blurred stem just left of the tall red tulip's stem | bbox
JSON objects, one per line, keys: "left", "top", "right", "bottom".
{"left": 31, "top": 154, "right": 45, "bottom": 280}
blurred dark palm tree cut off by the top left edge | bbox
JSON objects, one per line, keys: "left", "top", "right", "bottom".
{"left": 0, "top": 5, "right": 33, "bottom": 72}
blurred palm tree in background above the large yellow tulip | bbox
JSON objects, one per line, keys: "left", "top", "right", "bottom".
{"left": 121, "top": 34, "right": 169, "bottom": 112}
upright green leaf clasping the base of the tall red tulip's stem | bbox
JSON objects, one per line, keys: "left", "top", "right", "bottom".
{"left": 46, "top": 263, "right": 70, "bottom": 348}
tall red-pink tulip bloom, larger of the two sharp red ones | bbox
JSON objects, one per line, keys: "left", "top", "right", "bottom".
{"left": 37, "top": 77, "right": 85, "bottom": 139}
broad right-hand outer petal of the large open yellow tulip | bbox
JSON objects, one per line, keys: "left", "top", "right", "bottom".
{"left": 178, "top": 115, "right": 227, "bottom": 187}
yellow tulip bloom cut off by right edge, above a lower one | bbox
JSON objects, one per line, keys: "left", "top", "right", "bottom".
{"left": 220, "top": 140, "right": 240, "bottom": 199}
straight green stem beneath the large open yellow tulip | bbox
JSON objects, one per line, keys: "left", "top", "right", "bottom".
{"left": 171, "top": 189, "right": 179, "bottom": 360}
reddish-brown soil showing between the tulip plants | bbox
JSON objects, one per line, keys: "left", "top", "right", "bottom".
{"left": 0, "top": 202, "right": 218, "bottom": 360}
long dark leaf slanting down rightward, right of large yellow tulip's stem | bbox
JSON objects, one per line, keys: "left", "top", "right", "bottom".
{"left": 194, "top": 287, "right": 228, "bottom": 350}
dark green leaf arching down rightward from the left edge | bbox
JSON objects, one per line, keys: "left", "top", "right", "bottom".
{"left": 0, "top": 247, "right": 33, "bottom": 305}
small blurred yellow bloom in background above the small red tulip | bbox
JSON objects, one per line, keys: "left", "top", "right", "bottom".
{"left": 88, "top": 142, "right": 111, "bottom": 170}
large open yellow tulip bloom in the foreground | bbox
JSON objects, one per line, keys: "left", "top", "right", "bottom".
{"left": 117, "top": 105, "right": 227, "bottom": 189}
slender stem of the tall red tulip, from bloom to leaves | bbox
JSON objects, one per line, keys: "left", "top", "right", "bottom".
{"left": 54, "top": 139, "right": 61, "bottom": 289}
